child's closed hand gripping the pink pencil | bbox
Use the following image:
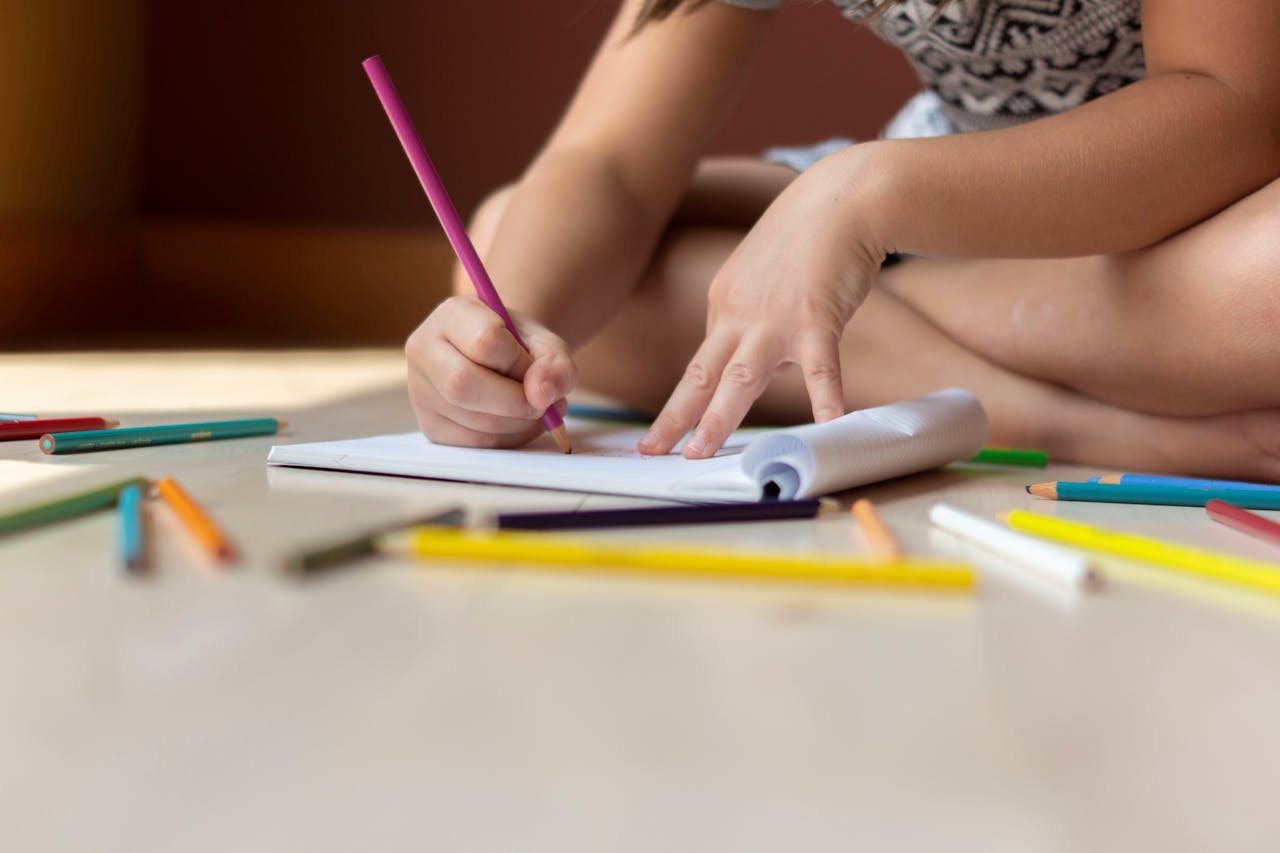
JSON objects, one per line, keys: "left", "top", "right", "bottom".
{"left": 404, "top": 296, "right": 577, "bottom": 447}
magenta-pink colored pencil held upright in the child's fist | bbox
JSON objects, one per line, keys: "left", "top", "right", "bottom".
{"left": 364, "top": 56, "right": 571, "bottom": 453}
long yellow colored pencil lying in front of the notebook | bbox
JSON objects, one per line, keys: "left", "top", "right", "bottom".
{"left": 381, "top": 528, "right": 974, "bottom": 588}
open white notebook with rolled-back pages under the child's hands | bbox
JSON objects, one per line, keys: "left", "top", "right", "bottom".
{"left": 266, "top": 388, "right": 987, "bottom": 502}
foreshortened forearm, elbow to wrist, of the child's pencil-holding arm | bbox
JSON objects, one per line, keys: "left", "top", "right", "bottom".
{"left": 485, "top": 149, "right": 663, "bottom": 346}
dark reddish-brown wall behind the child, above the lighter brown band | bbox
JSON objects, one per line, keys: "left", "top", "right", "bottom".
{"left": 142, "top": 0, "right": 914, "bottom": 224}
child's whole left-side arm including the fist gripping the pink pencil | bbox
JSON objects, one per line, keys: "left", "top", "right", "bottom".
{"left": 406, "top": 0, "right": 771, "bottom": 447}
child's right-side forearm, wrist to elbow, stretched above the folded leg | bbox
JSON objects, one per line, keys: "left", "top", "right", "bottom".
{"left": 834, "top": 74, "right": 1280, "bottom": 257}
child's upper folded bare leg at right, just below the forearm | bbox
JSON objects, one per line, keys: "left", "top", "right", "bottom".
{"left": 882, "top": 171, "right": 1280, "bottom": 415}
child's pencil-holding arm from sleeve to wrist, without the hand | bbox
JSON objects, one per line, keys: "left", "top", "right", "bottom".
{"left": 486, "top": 1, "right": 771, "bottom": 345}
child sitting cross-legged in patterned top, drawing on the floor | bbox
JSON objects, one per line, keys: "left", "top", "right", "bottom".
{"left": 407, "top": 0, "right": 1280, "bottom": 479}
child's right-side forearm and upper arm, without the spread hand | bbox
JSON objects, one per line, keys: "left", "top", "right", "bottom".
{"left": 849, "top": 0, "right": 1280, "bottom": 257}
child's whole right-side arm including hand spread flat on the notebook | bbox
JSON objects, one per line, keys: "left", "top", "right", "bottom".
{"left": 643, "top": 0, "right": 1280, "bottom": 456}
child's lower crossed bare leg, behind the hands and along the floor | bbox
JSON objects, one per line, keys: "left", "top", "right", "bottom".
{"left": 472, "top": 161, "right": 1280, "bottom": 479}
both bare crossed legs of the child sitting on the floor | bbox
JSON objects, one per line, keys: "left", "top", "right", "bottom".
{"left": 472, "top": 160, "right": 1280, "bottom": 479}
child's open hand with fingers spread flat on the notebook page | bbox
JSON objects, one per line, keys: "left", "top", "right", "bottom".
{"left": 640, "top": 165, "right": 884, "bottom": 459}
